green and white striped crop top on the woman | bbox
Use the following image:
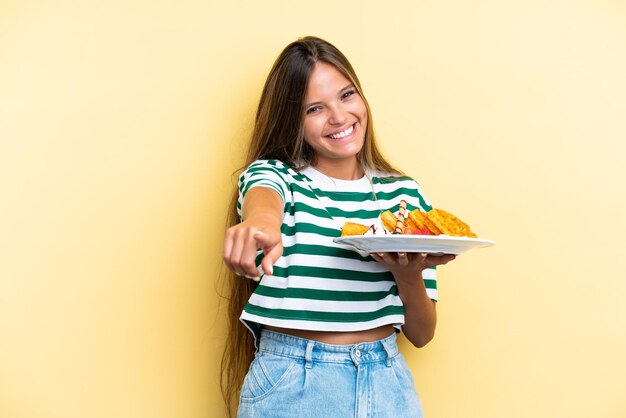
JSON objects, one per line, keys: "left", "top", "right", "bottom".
{"left": 238, "top": 160, "right": 437, "bottom": 335}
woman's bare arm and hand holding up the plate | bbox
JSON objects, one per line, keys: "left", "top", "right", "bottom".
{"left": 371, "top": 253, "right": 455, "bottom": 347}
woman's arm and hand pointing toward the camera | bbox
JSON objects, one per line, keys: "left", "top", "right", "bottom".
{"left": 223, "top": 187, "right": 283, "bottom": 280}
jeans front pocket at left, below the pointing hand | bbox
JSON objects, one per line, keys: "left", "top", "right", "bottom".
{"left": 241, "top": 353, "right": 298, "bottom": 400}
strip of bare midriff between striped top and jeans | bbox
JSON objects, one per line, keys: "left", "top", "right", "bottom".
{"left": 263, "top": 325, "right": 395, "bottom": 345}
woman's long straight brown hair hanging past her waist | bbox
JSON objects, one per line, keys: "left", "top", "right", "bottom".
{"left": 221, "top": 36, "right": 399, "bottom": 416}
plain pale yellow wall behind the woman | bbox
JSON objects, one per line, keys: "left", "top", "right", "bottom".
{"left": 0, "top": 0, "right": 626, "bottom": 418}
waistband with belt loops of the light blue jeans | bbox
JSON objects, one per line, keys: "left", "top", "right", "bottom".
{"left": 259, "top": 329, "right": 398, "bottom": 367}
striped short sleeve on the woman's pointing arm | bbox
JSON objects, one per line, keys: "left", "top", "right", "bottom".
{"left": 237, "top": 160, "right": 289, "bottom": 219}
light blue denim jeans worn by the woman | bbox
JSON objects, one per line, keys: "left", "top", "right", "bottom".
{"left": 237, "top": 330, "right": 423, "bottom": 418}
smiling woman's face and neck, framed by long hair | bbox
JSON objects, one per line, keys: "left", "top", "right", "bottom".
{"left": 304, "top": 61, "right": 367, "bottom": 178}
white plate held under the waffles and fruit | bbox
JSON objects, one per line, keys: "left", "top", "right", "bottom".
{"left": 333, "top": 235, "right": 495, "bottom": 254}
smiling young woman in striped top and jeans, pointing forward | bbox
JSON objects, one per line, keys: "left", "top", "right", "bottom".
{"left": 222, "top": 37, "right": 454, "bottom": 418}
